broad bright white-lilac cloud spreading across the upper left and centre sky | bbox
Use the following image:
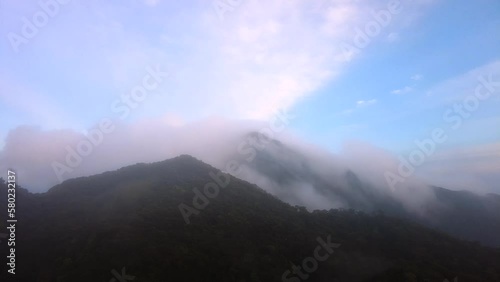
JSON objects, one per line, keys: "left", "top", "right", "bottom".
{"left": 11, "top": 0, "right": 436, "bottom": 123}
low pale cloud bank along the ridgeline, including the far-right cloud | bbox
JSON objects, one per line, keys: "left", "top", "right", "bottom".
{"left": 0, "top": 118, "right": 500, "bottom": 200}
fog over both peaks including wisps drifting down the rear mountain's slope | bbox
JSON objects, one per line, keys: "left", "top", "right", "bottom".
{"left": 0, "top": 118, "right": 500, "bottom": 212}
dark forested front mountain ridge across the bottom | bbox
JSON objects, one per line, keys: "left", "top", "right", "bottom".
{"left": 0, "top": 155, "right": 500, "bottom": 282}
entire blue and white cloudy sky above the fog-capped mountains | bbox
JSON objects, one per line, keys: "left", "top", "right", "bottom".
{"left": 0, "top": 0, "right": 500, "bottom": 193}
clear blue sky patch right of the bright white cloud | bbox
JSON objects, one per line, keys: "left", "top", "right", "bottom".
{"left": 297, "top": 1, "right": 500, "bottom": 150}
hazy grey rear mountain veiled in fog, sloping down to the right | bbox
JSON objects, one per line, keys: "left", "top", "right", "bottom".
{"left": 226, "top": 132, "right": 500, "bottom": 247}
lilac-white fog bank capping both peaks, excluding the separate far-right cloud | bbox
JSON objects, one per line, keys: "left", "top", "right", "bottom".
{"left": 0, "top": 118, "right": 442, "bottom": 198}
